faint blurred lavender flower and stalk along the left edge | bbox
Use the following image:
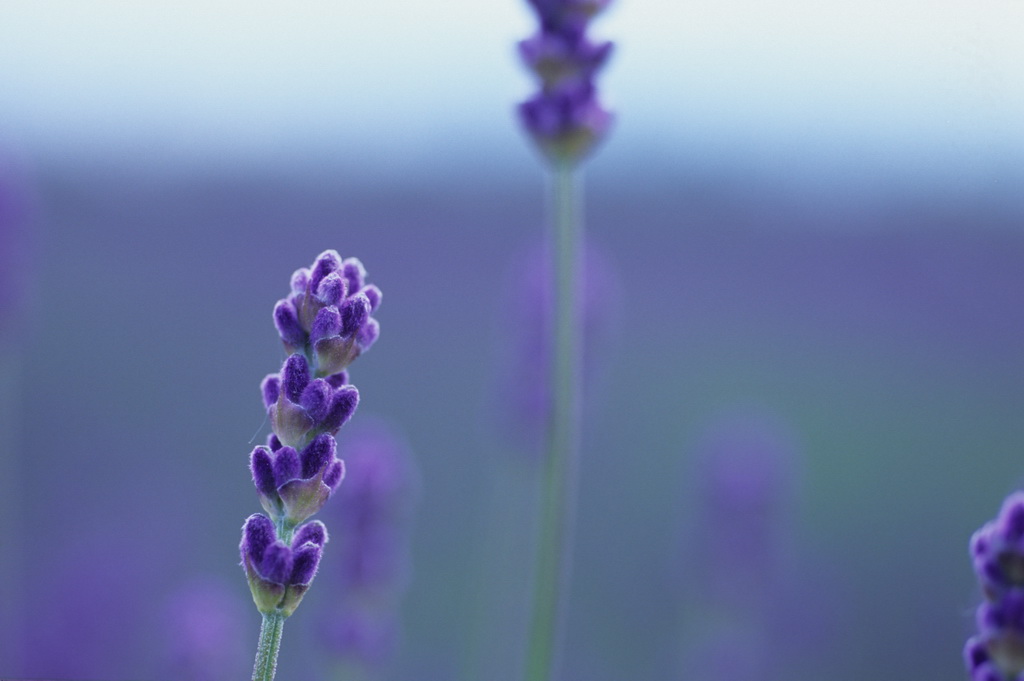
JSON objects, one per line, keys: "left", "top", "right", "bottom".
{"left": 0, "top": 160, "right": 28, "bottom": 674}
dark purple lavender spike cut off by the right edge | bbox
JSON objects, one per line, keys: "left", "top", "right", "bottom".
{"left": 964, "top": 492, "right": 1024, "bottom": 681}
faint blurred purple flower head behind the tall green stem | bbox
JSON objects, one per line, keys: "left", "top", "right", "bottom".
{"left": 496, "top": 238, "right": 621, "bottom": 456}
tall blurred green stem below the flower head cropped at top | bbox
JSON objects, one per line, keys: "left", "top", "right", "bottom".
{"left": 525, "top": 165, "right": 583, "bottom": 681}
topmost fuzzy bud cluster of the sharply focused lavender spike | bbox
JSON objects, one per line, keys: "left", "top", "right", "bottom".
{"left": 273, "top": 251, "right": 381, "bottom": 368}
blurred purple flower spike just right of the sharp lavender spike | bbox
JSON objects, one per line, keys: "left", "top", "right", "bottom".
{"left": 321, "top": 421, "right": 419, "bottom": 681}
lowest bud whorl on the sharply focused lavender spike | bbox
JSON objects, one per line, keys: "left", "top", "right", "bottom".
{"left": 239, "top": 513, "right": 328, "bottom": 616}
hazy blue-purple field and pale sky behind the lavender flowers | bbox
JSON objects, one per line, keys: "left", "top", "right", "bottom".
{"left": 0, "top": 0, "right": 1024, "bottom": 681}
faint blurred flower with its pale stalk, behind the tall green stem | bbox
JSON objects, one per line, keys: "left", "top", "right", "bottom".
{"left": 463, "top": 242, "right": 622, "bottom": 681}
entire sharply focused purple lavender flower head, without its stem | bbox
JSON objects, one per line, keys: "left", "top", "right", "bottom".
{"left": 240, "top": 251, "right": 381, "bottom": 616}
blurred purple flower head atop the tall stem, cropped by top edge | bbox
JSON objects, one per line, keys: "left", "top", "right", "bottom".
{"left": 519, "top": 0, "right": 612, "bottom": 165}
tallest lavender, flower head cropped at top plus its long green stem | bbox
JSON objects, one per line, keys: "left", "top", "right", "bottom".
{"left": 519, "top": 0, "right": 611, "bottom": 681}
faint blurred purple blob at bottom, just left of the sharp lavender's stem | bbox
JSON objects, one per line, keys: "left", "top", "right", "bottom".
{"left": 165, "top": 580, "right": 249, "bottom": 681}
